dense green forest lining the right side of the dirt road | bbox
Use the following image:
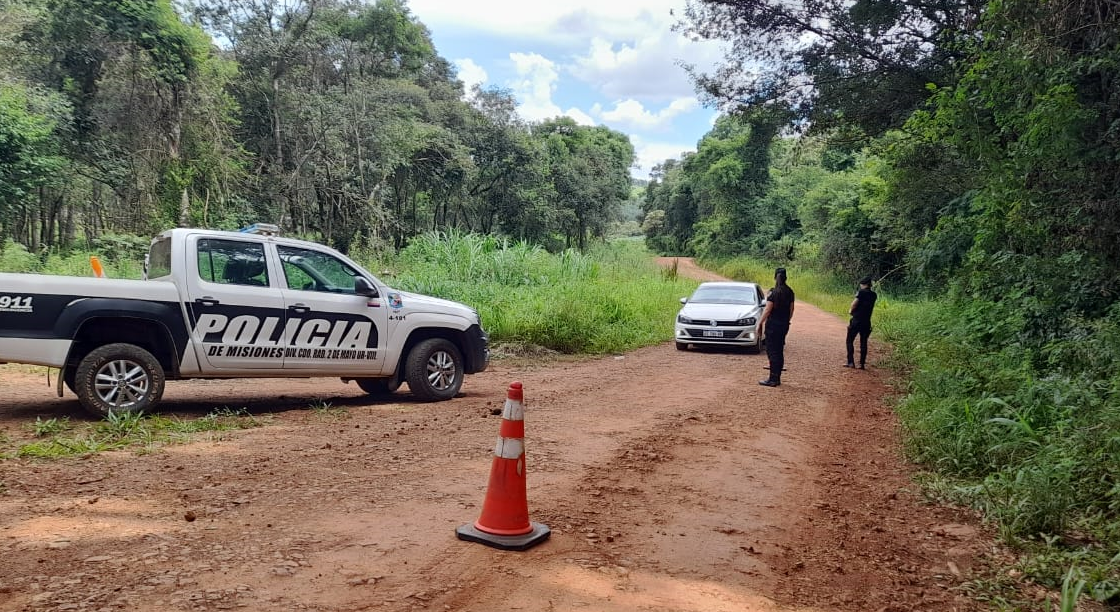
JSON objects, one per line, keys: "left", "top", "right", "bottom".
{"left": 644, "top": 0, "right": 1120, "bottom": 302}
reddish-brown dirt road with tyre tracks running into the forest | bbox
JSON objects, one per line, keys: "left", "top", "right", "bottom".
{"left": 0, "top": 260, "right": 990, "bottom": 612}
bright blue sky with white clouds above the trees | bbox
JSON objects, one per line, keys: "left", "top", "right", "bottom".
{"left": 408, "top": 0, "right": 722, "bottom": 178}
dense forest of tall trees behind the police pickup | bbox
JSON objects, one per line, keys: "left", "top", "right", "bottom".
{"left": 0, "top": 0, "right": 634, "bottom": 252}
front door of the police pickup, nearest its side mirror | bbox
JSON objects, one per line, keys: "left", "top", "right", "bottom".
{"left": 277, "top": 244, "right": 389, "bottom": 375}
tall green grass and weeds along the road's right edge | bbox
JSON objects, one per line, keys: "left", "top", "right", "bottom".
{"left": 890, "top": 293, "right": 1120, "bottom": 603}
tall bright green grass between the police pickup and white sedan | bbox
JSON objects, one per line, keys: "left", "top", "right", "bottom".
{"left": 373, "top": 233, "right": 697, "bottom": 354}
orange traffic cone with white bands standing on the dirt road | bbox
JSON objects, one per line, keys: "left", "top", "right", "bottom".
{"left": 455, "top": 382, "right": 552, "bottom": 550}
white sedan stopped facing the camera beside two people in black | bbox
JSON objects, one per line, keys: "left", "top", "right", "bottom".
{"left": 675, "top": 281, "right": 766, "bottom": 352}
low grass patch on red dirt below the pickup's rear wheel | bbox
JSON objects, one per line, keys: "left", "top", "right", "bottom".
{"left": 8, "top": 408, "right": 265, "bottom": 460}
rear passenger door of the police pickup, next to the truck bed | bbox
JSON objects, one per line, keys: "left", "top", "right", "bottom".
{"left": 186, "top": 235, "right": 287, "bottom": 372}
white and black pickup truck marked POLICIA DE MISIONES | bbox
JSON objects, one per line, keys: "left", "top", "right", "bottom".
{"left": 0, "top": 224, "right": 489, "bottom": 415}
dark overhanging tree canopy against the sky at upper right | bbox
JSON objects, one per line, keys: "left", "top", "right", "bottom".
{"left": 683, "top": 0, "right": 988, "bottom": 135}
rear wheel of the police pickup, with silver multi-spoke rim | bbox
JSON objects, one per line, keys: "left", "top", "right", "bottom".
{"left": 74, "top": 343, "right": 165, "bottom": 417}
